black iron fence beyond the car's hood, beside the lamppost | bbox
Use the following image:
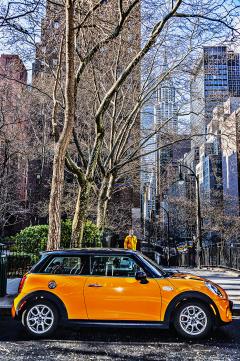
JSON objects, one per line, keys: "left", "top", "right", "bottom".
{"left": 179, "top": 243, "right": 240, "bottom": 270}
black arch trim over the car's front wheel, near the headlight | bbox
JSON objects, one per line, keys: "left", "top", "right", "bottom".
{"left": 164, "top": 291, "right": 220, "bottom": 325}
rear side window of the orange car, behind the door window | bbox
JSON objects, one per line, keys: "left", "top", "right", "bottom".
{"left": 43, "top": 256, "right": 89, "bottom": 276}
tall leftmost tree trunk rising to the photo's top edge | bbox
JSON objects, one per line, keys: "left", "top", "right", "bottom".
{"left": 47, "top": 0, "right": 75, "bottom": 250}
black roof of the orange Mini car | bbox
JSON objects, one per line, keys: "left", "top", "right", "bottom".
{"left": 42, "top": 248, "right": 139, "bottom": 256}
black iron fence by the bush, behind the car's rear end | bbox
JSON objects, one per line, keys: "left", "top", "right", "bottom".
{"left": 1, "top": 243, "right": 40, "bottom": 278}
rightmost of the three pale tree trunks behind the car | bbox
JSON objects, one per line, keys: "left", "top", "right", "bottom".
{"left": 97, "top": 174, "right": 114, "bottom": 230}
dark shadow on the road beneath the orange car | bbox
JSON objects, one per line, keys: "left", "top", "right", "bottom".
{"left": 0, "top": 318, "right": 240, "bottom": 345}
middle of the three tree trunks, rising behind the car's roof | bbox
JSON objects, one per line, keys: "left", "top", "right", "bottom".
{"left": 71, "top": 181, "right": 92, "bottom": 248}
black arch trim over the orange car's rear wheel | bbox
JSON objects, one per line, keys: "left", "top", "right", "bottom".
{"left": 16, "top": 291, "right": 68, "bottom": 320}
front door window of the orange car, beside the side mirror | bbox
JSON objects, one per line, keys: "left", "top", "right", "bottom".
{"left": 90, "top": 256, "right": 142, "bottom": 277}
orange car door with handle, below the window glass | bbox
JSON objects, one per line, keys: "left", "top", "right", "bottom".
{"left": 84, "top": 276, "right": 161, "bottom": 321}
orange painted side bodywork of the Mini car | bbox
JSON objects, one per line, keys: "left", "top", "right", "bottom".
{"left": 12, "top": 273, "right": 232, "bottom": 322}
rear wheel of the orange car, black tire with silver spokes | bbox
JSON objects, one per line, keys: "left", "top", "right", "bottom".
{"left": 22, "top": 300, "right": 59, "bottom": 338}
